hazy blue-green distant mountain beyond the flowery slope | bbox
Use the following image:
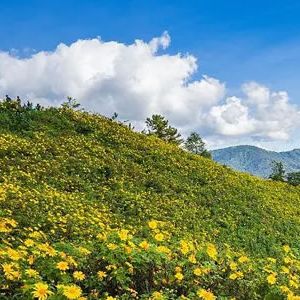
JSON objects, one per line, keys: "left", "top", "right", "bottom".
{"left": 212, "top": 145, "right": 300, "bottom": 177}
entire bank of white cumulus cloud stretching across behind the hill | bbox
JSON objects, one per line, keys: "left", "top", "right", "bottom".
{"left": 0, "top": 32, "right": 299, "bottom": 148}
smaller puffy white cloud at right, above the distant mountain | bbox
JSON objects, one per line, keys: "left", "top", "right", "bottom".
{"left": 206, "top": 82, "right": 300, "bottom": 141}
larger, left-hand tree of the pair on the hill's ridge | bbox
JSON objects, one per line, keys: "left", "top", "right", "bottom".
{"left": 146, "top": 115, "right": 182, "bottom": 145}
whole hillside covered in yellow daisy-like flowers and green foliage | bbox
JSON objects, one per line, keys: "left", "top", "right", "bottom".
{"left": 0, "top": 103, "right": 300, "bottom": 300}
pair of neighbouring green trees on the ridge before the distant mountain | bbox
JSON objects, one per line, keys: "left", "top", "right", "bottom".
{"left": 145, "top": 115, "right": 211, "bottom": 158}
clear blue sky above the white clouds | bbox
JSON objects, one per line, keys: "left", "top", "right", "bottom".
{"left": 0, "top": 0, "right": 300, "bottom": 149}
